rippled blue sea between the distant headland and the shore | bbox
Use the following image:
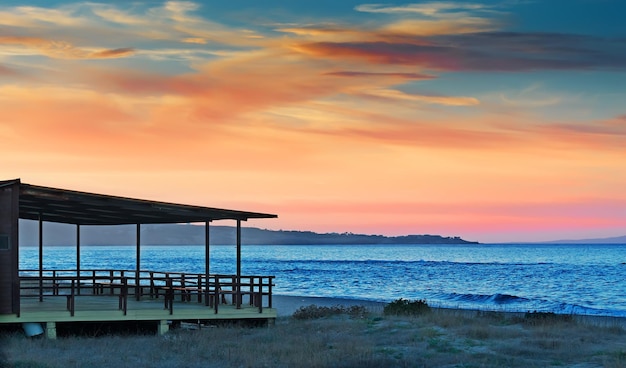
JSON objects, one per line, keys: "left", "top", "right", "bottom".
{"left": 19, "top": 244, "right": 626, "bottom": 317}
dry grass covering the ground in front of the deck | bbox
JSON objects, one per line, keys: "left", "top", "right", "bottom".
{"left": 0, "top": 309, "right": 626, "bottom": 368}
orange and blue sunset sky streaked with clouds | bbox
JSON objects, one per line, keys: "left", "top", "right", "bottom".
{"left": 0, "top": 0, "right": 626, "bottom": 242}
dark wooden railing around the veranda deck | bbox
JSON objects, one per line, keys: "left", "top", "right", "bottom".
{"left": 19, "top": 269, "right": 274, "bottom": 316}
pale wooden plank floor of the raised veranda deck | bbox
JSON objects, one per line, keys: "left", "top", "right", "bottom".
{"left": 0, "top": 295, "right": 277, "bottom": 324}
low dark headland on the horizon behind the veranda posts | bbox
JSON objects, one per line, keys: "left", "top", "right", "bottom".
{"left": 20, "top": 221, "right": 479, "bottom": 246}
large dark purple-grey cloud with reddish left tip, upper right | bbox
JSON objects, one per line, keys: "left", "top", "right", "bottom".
{"left": 300, "top": 32, "right": 626, "bottom": 72}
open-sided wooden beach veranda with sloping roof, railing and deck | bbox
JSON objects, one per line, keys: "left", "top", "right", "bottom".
{"left": 0, "top": 179, "right": 277, "bottom": 337}
